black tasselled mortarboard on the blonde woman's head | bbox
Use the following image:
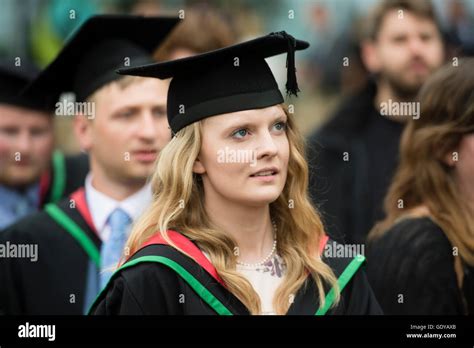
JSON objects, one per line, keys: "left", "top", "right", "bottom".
{"left": 118, "top": 32, "right": 309, "bottom": 133}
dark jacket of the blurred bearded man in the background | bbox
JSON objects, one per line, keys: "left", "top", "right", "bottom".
{"left": 307, "top": 81, "right": 403, "bottom": 244}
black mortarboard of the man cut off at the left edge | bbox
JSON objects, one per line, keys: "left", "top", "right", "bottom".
{"left": 0, "top": 57, "right": 47, "bottom": 111}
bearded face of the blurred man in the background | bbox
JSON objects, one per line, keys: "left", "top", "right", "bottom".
{"left": 369, "top": 10, "right": 444, "bottom": 97}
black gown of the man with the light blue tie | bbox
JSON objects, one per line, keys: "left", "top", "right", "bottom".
{"left": 0, "top": 191, "right": 101, "bottom": 315}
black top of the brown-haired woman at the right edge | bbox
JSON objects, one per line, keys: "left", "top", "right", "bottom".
{"left": 367, "top": 217, "right": 464, "bottom": 315}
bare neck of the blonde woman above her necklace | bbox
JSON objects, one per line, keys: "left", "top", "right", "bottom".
{"left": 205, "top": 193, "right": 274, "bottom": 263}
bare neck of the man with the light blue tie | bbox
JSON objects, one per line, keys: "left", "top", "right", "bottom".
{"left": 91, "top": 161, "right": 146, "bottom": 201}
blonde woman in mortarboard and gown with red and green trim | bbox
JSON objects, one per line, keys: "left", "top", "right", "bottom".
{"left": 89, "top": 32, "right": 381, "bottom": 315}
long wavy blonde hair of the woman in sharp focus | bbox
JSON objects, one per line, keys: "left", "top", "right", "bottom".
{"left": 126, "top": 104, "right": 339, "bottom": 314}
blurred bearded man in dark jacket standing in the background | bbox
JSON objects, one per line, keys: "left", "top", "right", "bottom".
{"left": 308, "top": 0, "right": 444, "bottom": 243}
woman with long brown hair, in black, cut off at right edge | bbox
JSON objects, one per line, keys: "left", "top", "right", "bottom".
{"left": 368, "top": 59, "right": 474, "bottom": 315}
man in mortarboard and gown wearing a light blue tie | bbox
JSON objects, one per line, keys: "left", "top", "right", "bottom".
{"left": 0, "top": 15, "right": 179, "bottom": 314}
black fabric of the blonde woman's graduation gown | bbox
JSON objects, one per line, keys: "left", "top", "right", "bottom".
{"left": 90, "top": 235, "right": 382, "bottom": 315}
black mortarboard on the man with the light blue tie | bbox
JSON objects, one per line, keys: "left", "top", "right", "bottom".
{"left": 24, "top": 15, "right": 179, "bottom": 108}
